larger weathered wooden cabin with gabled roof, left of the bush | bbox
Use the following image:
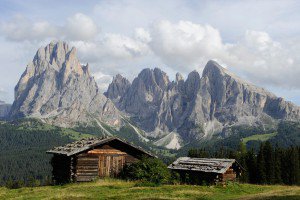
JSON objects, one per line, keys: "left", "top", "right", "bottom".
{"left": 47, "top": 137, "right": 155, "bottom": 184}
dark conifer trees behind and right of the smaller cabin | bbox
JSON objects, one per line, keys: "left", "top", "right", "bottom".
{"left": 188, "top": 141, "right": 300, "bottom": 185}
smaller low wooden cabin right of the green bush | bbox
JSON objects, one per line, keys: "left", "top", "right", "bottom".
{"left": 168, "top": 157, "right": 243, "bottom": 184}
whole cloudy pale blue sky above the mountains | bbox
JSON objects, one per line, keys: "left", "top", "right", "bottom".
{"left": 0, "top": 0, "right": 300, "bottom": 105}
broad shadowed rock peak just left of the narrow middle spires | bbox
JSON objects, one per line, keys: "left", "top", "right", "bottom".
{"left": 119, "top": 68, "right": 170, "bottom": 132}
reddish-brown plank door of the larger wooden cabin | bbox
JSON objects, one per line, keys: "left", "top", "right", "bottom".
{"left": 99, "top": 155, "right": 125, "bottom": 177}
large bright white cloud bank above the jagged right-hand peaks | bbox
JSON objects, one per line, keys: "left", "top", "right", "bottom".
{"left": 65, "top": 20, "right": 300, "bottom": 91}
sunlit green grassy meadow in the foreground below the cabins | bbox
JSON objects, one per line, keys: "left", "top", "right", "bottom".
{"left": 0, "top": 180, "right": 300, "bottom": 200}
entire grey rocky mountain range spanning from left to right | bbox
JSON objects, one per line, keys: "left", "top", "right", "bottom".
{"left": 9, "top": 42, "right": 300, "bottom": 149}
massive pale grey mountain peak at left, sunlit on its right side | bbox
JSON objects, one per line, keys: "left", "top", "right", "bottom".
{"left": 10, "top": 42, "right": 120, "bottom": 126}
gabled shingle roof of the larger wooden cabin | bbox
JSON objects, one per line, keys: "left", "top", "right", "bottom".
{"left": 47, "top": 136, "right": 156, "bottom": 157}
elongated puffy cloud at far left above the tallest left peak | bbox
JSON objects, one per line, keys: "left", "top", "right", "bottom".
{"left": 0, "top": 13, "right": 98, "bottom": 42}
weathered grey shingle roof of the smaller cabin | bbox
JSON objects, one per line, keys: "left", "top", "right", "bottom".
{"left": 168, "top": 157, "right": 236, "bottom": 174}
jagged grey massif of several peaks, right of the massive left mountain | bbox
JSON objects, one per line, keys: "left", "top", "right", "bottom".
{"left": 106, "top": 61, "right": 300, "bottom": 148}
